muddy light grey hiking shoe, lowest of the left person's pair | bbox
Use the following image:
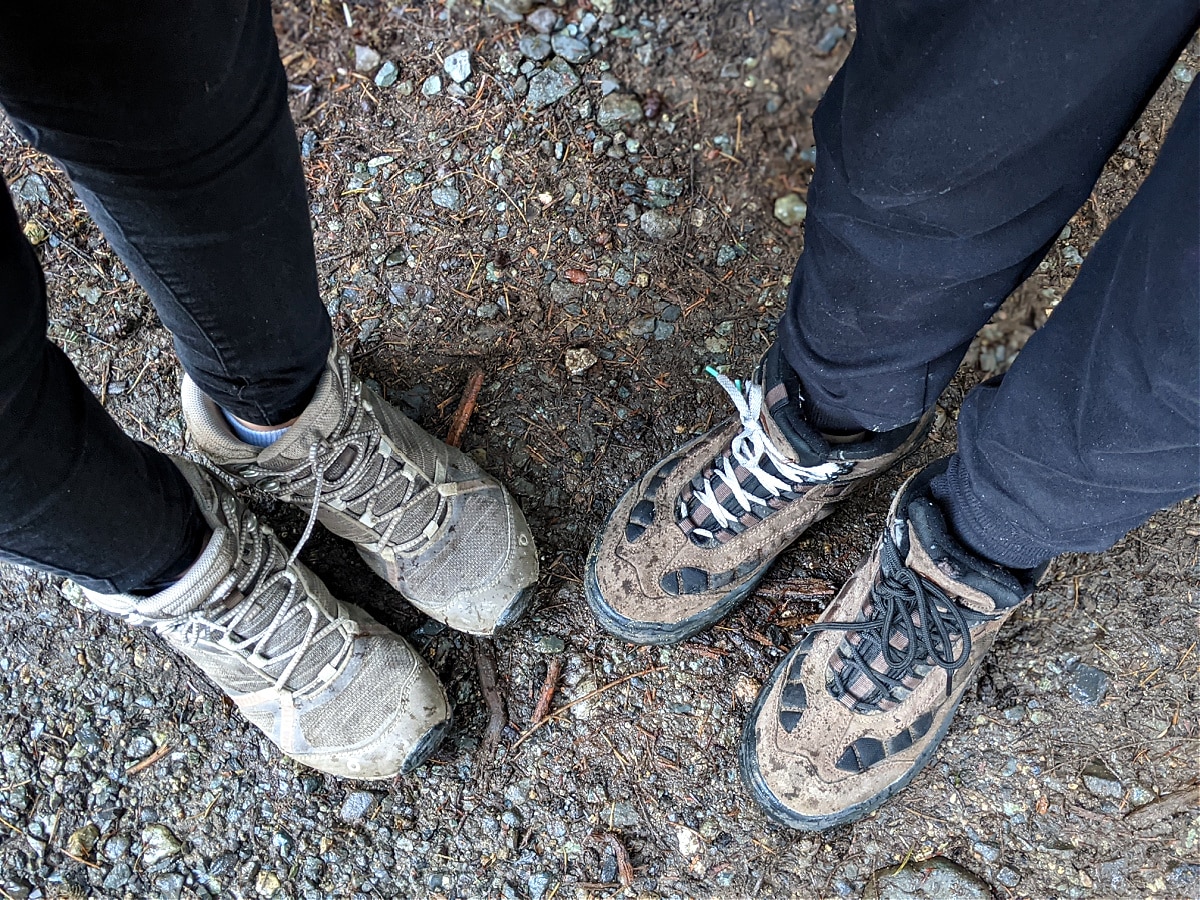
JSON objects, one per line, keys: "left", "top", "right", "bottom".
{"left": 84, "top": 460, "right": 450, "bottom": 779}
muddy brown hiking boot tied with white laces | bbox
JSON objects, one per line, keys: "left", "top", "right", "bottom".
{"left": 584, "top": 347, "right": 931, "bottom": 644}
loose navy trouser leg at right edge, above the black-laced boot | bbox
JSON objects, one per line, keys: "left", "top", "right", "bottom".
{"left": 934, "top": 85, "right": 1200, "bottom": 568}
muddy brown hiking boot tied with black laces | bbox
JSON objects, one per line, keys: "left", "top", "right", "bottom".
{"left": 739, "top": 460, "right": 1037, "bottom": 830}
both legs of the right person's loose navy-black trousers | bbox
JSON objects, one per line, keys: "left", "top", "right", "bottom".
{"left": 779, "top": 0, "right": 1200, "bottom": 568}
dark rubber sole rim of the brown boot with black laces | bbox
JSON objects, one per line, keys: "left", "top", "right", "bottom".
{"left": 738, "top": 650, "right": 962, "bottom": 832}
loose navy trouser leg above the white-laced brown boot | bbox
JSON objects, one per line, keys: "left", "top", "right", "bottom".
{"left": 779, "top": 0, "right": 1198, "bottom": 431}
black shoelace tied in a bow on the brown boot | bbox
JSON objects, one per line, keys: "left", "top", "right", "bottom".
{"left": 810, "top": 538, "right": 989, "bottom": 709}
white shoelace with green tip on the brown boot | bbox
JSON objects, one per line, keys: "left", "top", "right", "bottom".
{"left": 679, "top": 366, "right": 841, "bottom": 538}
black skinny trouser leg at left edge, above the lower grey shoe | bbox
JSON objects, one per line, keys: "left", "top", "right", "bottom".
{"left": 0, "top": 186, "right": 206, "bottom": 593}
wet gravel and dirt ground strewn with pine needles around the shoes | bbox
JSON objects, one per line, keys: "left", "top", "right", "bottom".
{"left": 0, "top": 0, "right": 1200, "bottom": 900}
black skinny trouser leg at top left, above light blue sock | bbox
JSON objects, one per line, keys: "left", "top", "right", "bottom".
{"left": 0, "top": 0, "right": 332, "bottom": 424}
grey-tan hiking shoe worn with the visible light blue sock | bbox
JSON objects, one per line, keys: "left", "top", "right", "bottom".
{"left": 184, "top": 344, "right": 538, "bottom": 635}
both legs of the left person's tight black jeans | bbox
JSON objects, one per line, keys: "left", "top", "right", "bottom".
{"left": 0, "top": 0, "right": 332, "bottom": 592}
